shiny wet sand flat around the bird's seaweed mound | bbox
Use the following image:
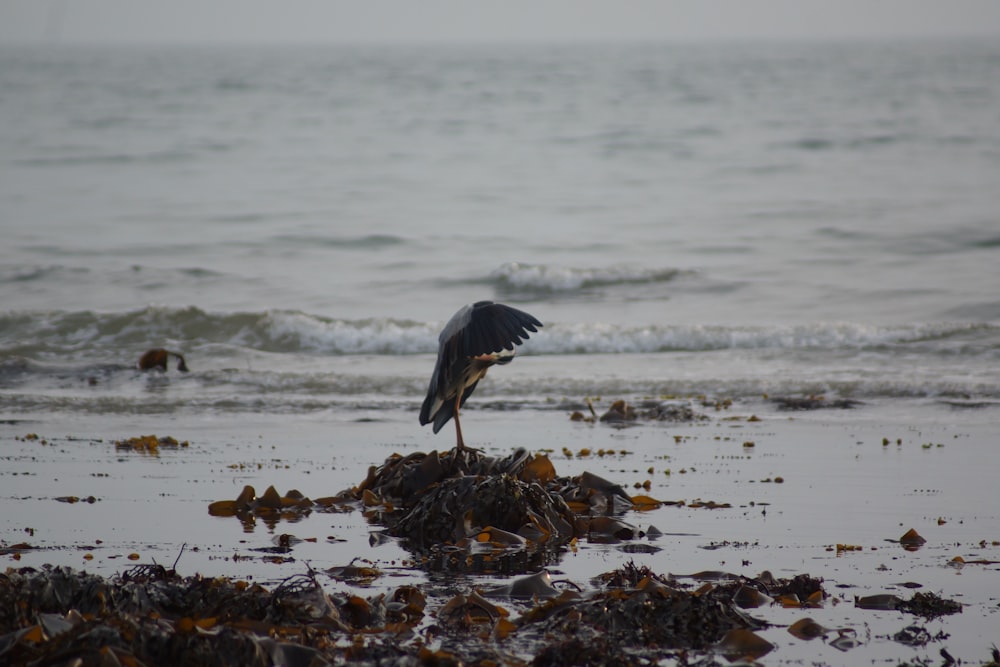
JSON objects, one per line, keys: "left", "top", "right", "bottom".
{"left": 0, "top": 402, "right": 1000, "bottom": 664}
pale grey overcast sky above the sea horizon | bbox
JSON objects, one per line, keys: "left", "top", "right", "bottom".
{"left": 0, "top": 0, "right": 1000, "bottom": 43}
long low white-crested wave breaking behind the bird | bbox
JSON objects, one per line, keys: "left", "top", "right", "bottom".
{"left": 0, "top": 306, "right": 1000, "bottom": 360}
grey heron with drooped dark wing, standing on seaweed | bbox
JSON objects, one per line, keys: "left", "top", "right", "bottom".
{"left": 420, "top": 301, "right": 542, "bottom": 451}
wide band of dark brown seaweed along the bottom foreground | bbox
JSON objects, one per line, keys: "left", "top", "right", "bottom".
{"left": 0, "top": 561, "right": 961, "bottom": 667}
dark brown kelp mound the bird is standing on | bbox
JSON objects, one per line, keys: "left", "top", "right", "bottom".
{"left": 341, "top": 449, "right": 659, "bottom": 572}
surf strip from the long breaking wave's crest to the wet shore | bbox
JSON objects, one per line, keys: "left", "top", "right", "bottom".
{"left": 0, "top": 307, "right": 1000, "bottom": 414}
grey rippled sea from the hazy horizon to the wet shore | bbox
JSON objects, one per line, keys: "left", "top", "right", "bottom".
{"left": 0, "top": 42, "right": 1000, "bottom": 420}
